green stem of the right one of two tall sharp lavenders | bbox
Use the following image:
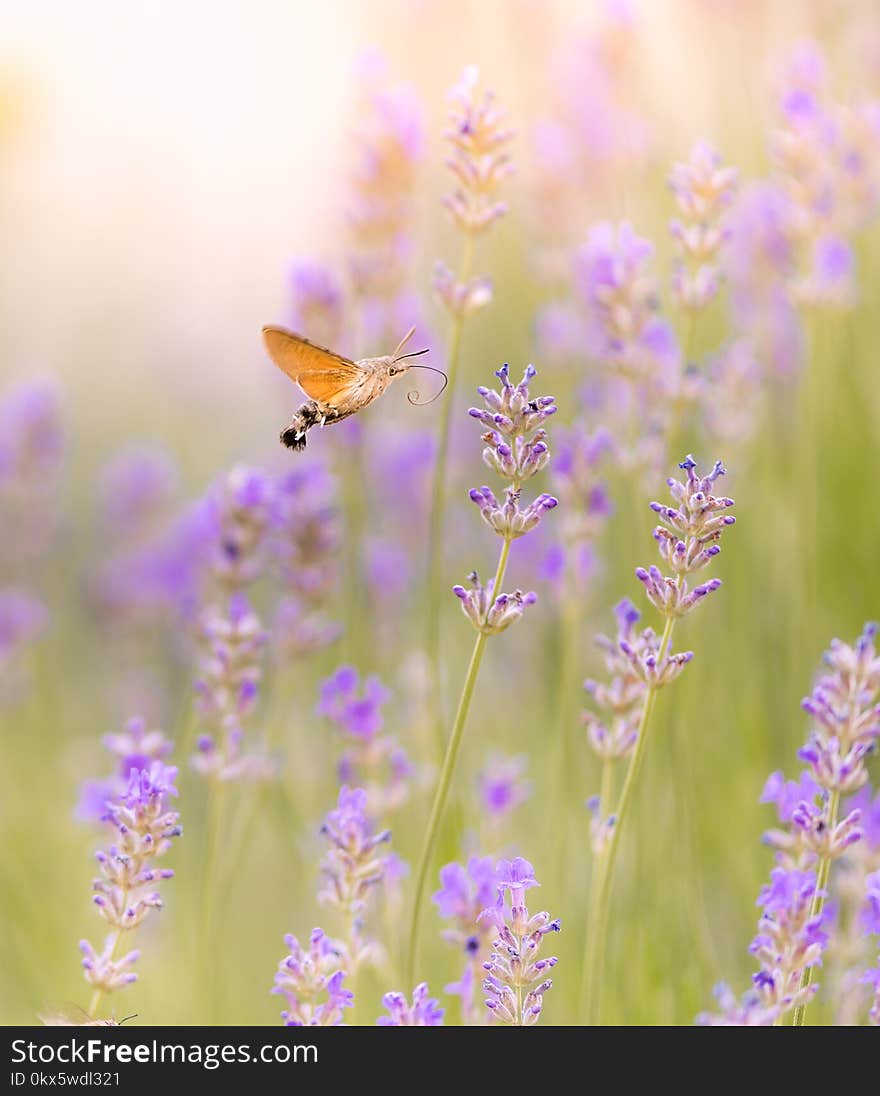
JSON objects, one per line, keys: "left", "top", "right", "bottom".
{"left": 581, "top": 617, "right": 675, "bottom": 1024}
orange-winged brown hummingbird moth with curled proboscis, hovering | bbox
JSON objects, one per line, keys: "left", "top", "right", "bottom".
{"left": 263, "top": 327, "right": 448, "bottom": 449}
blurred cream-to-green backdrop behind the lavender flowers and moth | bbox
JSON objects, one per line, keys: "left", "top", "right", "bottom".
{"left": 0, "top": 0, "right": 880, "bottom": 1024}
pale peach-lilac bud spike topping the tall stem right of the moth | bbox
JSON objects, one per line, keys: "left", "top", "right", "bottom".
{"left": 444, "top": 66, "right": 513, "bottom": 236}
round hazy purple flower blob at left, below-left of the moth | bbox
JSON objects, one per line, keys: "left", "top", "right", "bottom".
{"left": 98, "top": 445, "right": 180, "bottom": 544}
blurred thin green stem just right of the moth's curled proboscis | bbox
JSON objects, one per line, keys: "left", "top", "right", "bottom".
{"left": 425, "top": 235, "right": 473, "bottom": 751}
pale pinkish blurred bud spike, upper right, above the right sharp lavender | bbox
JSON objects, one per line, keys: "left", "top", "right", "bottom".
{"left": 670, "top": 142, "right": 738, "bottom": 312}
